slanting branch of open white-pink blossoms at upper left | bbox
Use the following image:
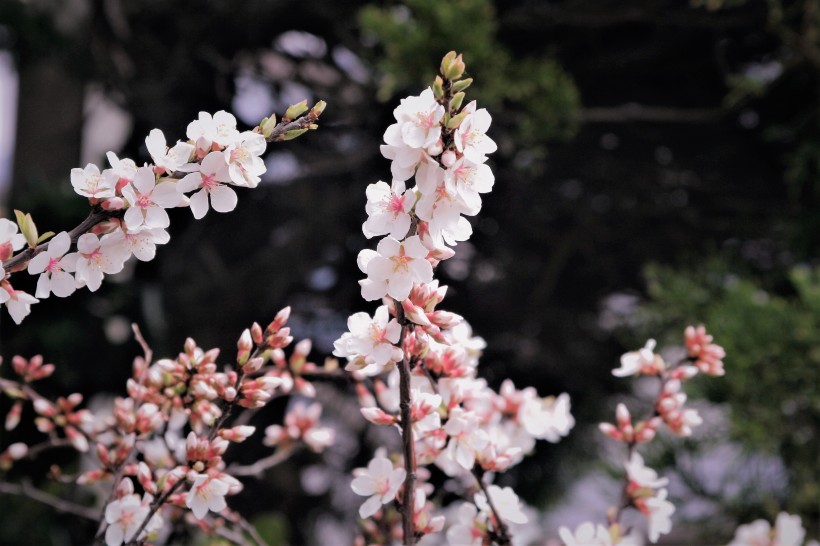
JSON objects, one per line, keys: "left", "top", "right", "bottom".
{"left": 0, "top": 102, "right": 324, "bottom": 324}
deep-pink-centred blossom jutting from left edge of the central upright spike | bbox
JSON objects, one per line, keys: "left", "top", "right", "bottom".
{"left": 362, "top": 181, "right": 416, "bottom": 239}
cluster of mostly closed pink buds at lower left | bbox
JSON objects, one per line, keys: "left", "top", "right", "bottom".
{"left": 0, "top": 308, "right": 334, "bottom": 546}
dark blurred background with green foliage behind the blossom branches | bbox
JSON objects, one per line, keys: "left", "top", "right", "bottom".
{"left": 0, "top": 0, "right": 820, "bottom": 544}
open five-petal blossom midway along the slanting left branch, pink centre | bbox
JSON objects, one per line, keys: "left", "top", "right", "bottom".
{"left": 122, "top": 167, "right": 185, "bottom": 231}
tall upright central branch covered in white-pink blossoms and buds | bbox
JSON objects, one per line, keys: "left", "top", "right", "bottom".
{"left": 334, "top": 53, "right": 574, "bottom": 544}
